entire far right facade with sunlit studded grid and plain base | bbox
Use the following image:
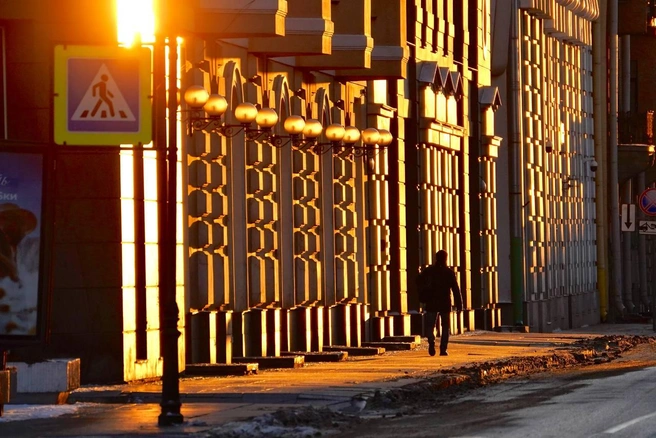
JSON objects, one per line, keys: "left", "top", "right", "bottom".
{"left": 492, "top": 1, "right": 599, "bottom": 332}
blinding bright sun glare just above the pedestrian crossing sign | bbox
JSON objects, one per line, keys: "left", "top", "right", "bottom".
{"left": 116, "top": 0, "right": 155, "bottom": 46}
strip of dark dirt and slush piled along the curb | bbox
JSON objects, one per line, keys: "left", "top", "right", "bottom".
{"left": 205, "top": 335, "right": 656, "bottom": 438}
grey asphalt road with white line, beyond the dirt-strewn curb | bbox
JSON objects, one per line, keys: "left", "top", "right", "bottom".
{"left": 345, "top": 346, "right": 656, "bottom": 438}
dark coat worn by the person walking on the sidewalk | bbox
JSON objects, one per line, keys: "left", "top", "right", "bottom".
{"left": 417, "top": 265, "right": 462, "bottom": 313}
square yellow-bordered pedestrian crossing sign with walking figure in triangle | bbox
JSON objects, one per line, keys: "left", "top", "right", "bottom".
{"left": 54, "top": 46, "right": 152, "bottom": 146}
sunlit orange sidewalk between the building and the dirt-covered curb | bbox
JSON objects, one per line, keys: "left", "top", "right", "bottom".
{"left": 0, "top": 324, "right": 656, "bottom": 437}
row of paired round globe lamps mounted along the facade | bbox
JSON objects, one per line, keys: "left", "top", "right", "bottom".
{"left": 184, "top": 85, "right": 393, "bottom": 156}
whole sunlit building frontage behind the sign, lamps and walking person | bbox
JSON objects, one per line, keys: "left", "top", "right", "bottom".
{"left": 0, "top": 0, "right": 599, "bottom": 382}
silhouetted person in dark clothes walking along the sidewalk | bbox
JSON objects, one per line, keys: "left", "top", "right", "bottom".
{"left": 418, "top": 250, "right": 462, "bottom": 356}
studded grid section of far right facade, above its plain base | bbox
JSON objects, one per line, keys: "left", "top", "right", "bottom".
{"left": 520, "top": 6, "right": 596, "bottom": 321}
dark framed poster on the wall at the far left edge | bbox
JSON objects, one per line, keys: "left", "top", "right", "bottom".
{"left": 0, "top": 151, "right": 44, "bottom": 341}
